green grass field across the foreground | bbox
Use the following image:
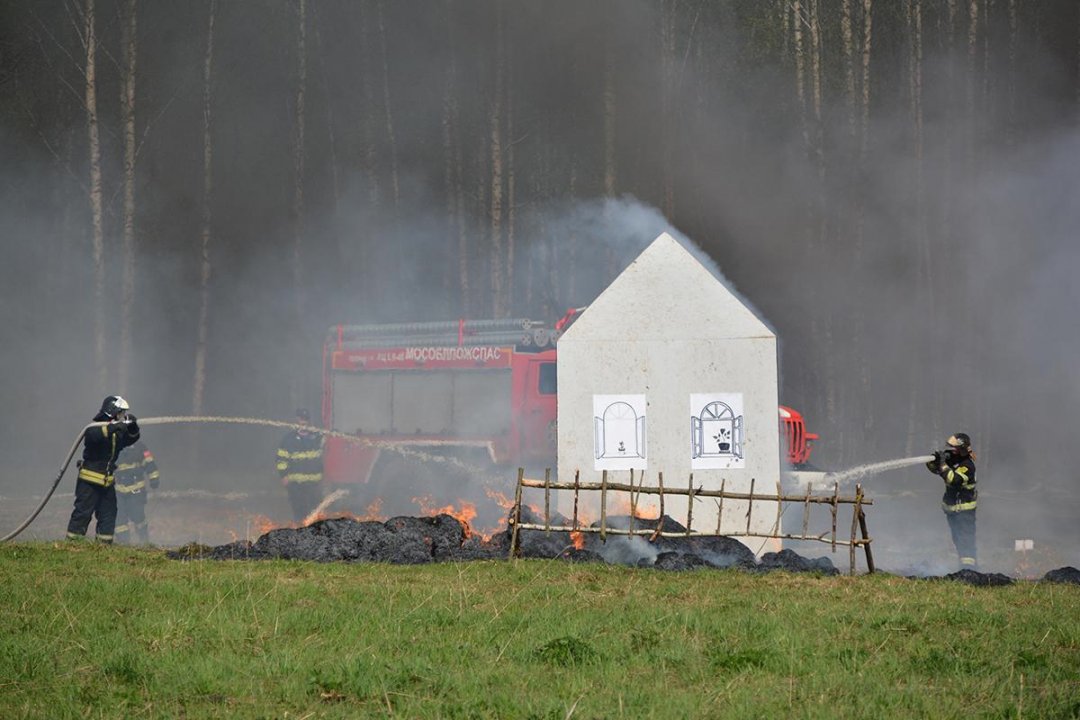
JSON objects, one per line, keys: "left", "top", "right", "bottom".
{"left": 0, "top": 543, "right": 1080, "bottom": 719}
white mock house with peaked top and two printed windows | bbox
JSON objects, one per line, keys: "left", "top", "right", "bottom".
{"left": 558, "top": 233, "right": 781, "bottom": 554}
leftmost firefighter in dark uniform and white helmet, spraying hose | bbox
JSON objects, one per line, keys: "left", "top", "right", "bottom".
{"left": 67, "top": 395, "right": 139, "bottom": 543}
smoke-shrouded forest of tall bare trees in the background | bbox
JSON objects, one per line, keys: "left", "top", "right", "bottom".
{"left": 0, "top": 0, "right": 1080, "bottom": 500}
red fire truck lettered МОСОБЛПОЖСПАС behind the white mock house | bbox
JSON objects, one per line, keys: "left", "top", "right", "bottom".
{"left": 323, "top": 309, "right": 818, "bottom": 490}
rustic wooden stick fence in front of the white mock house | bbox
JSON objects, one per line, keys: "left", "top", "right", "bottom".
{"left": 510, "top": 467, "right": 874, "bottom": 574}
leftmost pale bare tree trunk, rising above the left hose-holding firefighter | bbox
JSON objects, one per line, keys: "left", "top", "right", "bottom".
{"left": 83, "top": 0, "right": 109, "bottom": 388}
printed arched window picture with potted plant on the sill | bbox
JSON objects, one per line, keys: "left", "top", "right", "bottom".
{"left": 690, "top": 393, "right": 746, "bottom": 470}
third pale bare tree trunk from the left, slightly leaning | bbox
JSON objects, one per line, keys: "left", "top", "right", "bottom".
{"left": 191, "top": 0, "right": 217, "bottom": 416}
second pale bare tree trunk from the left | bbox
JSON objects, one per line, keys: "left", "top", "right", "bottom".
{"left": 119, "top": 0, "right": 138, "bottom": 392}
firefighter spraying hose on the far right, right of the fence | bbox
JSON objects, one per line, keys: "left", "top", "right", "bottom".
{"left": 927, "top": 433, "right": 978, "bottom": 570}
